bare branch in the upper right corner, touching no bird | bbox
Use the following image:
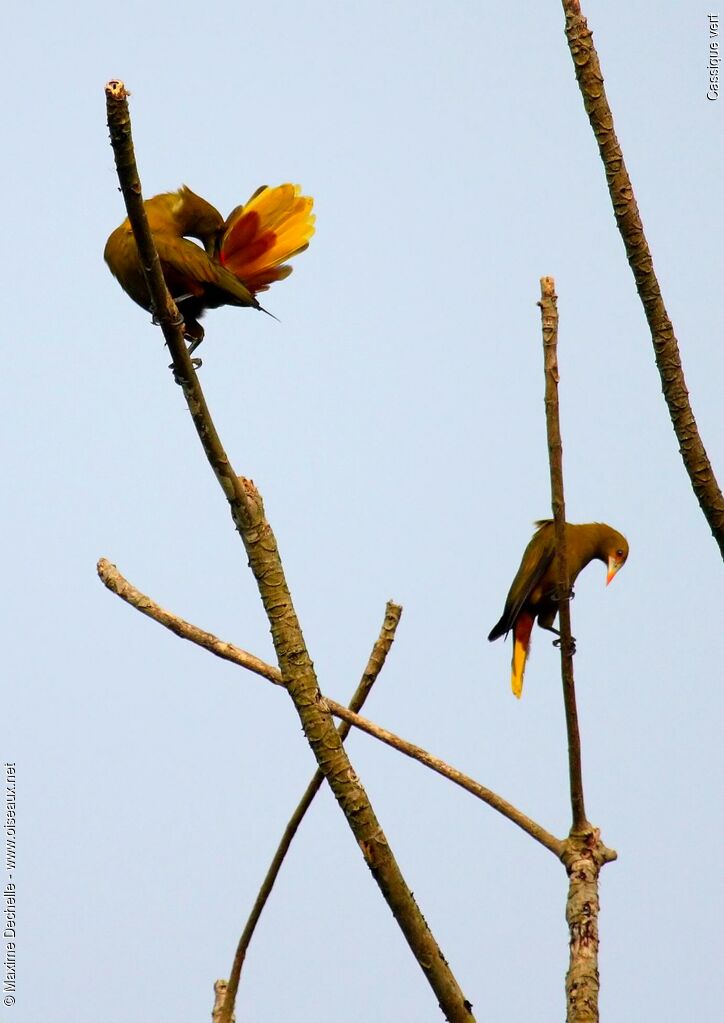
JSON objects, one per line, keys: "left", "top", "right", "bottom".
{"left": 562, "top": 0, "right": 724, "bottom": 558}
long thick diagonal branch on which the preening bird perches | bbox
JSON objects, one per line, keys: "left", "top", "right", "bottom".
{"left": 105, "top": 81, "right": 473, "bottom": 1023}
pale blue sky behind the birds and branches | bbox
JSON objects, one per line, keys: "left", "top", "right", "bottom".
{"left": 0, "top": 0, "right": 724, "bottom": 1023}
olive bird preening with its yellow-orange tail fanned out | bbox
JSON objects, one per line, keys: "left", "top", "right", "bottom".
{"left": 103, "top": 184, "right": 315, "bottom": 352}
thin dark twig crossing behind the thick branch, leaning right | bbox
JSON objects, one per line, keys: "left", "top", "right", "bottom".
{"left": 218, "top": 601, "right": 402, "bottom": 1023}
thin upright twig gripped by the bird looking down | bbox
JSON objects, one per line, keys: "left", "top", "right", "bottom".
{"left": 539, "top": 277, "right": 586, "bottom": 831}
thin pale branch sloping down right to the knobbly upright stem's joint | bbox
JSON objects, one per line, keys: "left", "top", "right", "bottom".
{"left": 98, "top": 559, "right": 564, "bottom": 857}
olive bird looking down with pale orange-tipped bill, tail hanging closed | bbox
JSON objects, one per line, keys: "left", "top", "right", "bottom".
{"left": 488, "top": 519, "right": 629, "bottom": 698}
